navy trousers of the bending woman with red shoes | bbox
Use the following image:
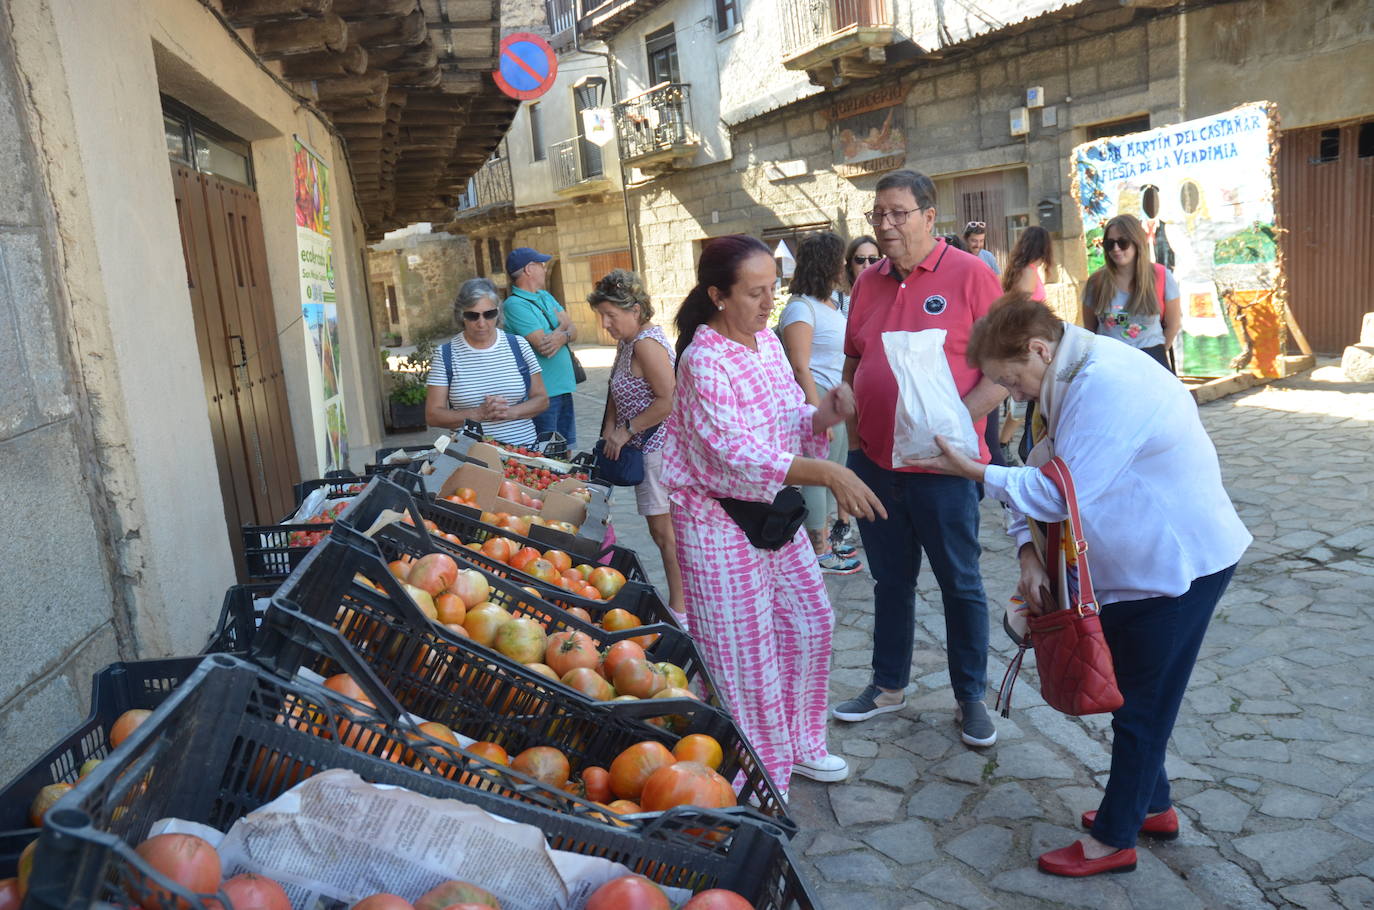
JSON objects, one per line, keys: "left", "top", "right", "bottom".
{"left": 1092, "top": 565, "right": 1235, "bottom": 848}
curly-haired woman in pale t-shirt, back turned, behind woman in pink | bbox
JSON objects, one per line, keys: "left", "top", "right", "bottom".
{"left": 778, "top": 231, "right": 863, "bottom": 575}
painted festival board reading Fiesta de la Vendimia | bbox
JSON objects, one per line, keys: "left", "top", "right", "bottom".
{"left": 1073, "top": 102, "right": 1285, "bottom": 377}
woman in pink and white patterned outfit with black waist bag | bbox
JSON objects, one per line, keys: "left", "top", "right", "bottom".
{"left": 664, "top": 235, "right": 882, "bottom": 793}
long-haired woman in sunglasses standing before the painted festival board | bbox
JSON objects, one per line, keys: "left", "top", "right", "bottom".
{"left": 1083, "top": 214, "right": 1183, "bottom": 371}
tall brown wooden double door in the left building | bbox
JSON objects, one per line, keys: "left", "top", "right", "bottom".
{"left": 172, "top": 162, "right": 300, "bottom": 577}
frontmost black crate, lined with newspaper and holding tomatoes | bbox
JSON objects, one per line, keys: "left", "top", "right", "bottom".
{"left": 26, "top": 654, "right": 818, "bottom": 910}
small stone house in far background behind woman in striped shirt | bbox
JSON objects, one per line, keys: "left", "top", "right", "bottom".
{"left": 367, "top": 224, "right": 477, "bottom": 345}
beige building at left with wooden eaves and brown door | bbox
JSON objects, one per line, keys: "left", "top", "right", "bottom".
{"left": 0, "top": 0, "right": 514, "bottom": 779}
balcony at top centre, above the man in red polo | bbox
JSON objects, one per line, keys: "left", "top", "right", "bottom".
{"left": 782, "top": 0, "right": 900, "bottom": 88}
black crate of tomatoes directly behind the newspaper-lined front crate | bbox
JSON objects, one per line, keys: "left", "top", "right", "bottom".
{"left": 243, "top": 538, "right": 797, "bottom": 834}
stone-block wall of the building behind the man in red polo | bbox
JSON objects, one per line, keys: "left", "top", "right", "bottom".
{"left": 628, "top": 10, "right": 1180, "bottom": 326}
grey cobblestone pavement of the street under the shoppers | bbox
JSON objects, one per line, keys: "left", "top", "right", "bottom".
{"left": 384, "top": 348, "right": 1374, "bottom": 910}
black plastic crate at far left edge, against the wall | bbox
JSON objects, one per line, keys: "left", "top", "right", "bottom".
{"left": 0, "top": 657, "right": 201, "bottom": 878}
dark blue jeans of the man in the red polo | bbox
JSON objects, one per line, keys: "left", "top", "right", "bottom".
{"left": 848, "top": 450, "right": 988, "bottom": 701}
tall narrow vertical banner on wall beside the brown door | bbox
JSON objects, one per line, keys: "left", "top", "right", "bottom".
{"left": 294, "top": 139, "right": 348, "bottom": 477}
